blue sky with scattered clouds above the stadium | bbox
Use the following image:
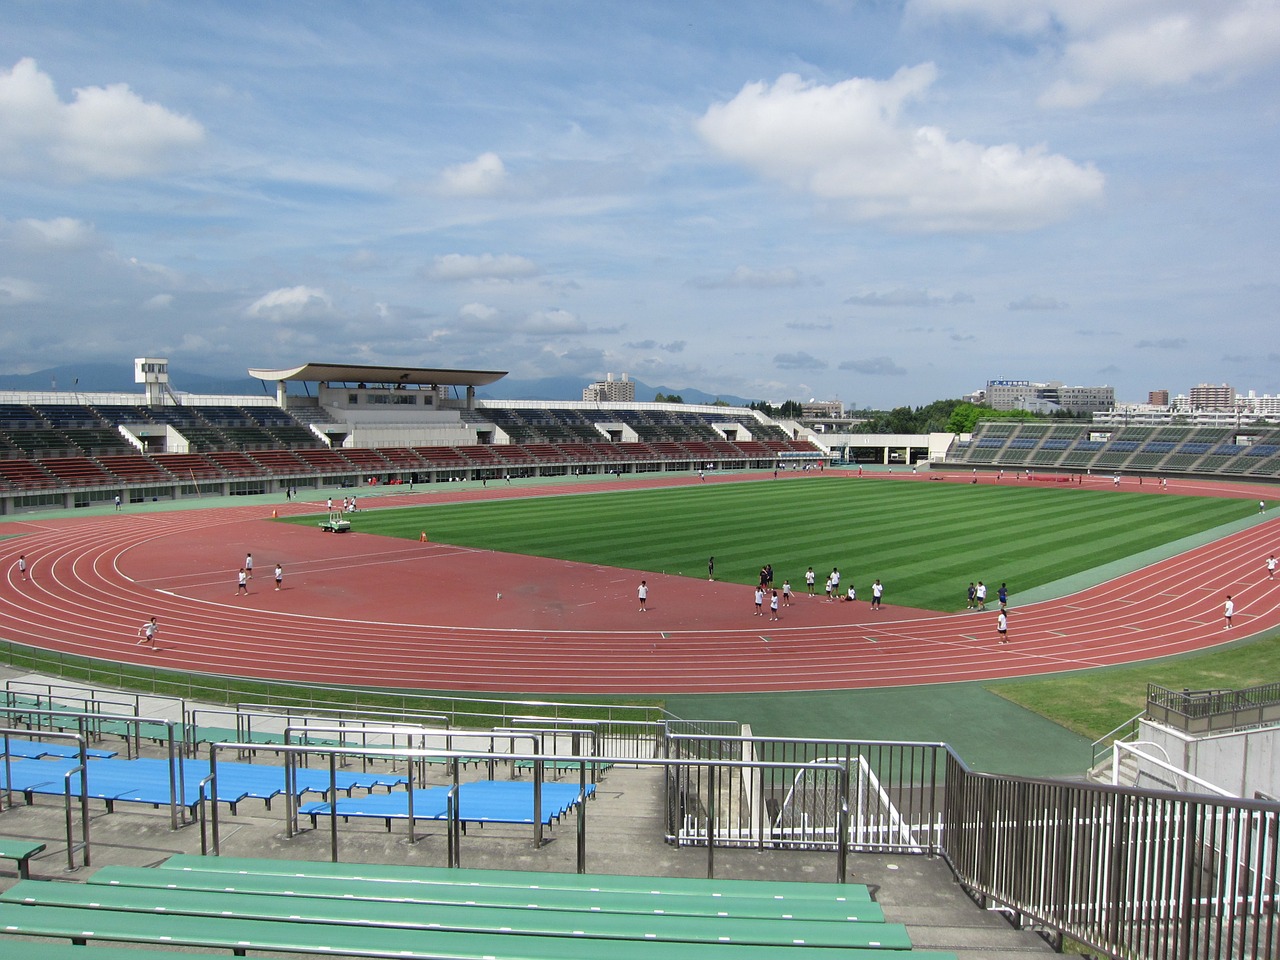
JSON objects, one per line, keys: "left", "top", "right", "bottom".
{"left": 0, "top": 0, "right": 1280, "bottom": 408}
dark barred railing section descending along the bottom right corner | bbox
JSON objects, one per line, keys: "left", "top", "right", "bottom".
{"left": 941, "top": 754, "right": 1280, "bottom": 960}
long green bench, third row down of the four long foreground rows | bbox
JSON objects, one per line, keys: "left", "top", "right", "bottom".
{"left": 0, "top": 881, "right": 911, "bottom": 950}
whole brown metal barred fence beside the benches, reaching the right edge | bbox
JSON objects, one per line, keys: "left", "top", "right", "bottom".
{"left": 667, "top": 736, "right": 1280, "bottom": 960}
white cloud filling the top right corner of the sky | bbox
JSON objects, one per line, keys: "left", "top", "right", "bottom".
{"left": 911, "top": 0, "right": 1280, "bottom": 108}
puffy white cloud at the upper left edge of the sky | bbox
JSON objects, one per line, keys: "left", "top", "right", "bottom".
{"left": 0, "top": 58, "right": 205, "bottom": 179}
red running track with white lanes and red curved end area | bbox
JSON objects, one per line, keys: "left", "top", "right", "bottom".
{"left": 0, "top": 475, "right": 1280, "bottom": 694}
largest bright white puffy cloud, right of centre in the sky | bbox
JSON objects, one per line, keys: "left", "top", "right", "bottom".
{"left": 698, "top": 64, "right": 1103, "bottom": 230}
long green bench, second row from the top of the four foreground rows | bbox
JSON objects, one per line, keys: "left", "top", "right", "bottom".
{"left": 88, "top": 867, "right": 884, "bottom": 923}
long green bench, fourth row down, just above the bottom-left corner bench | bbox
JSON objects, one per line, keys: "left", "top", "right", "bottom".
{"left": 0, "top": 906, "right": 955, "bottom": 960}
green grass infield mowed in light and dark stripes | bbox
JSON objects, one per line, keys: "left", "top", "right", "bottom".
{"left": 294, "top": 477, "right": 1253, "bottom": 611}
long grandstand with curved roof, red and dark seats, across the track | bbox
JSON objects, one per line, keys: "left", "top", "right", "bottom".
{"left": 0, "top": 358, "right": 828, "bottom": 513}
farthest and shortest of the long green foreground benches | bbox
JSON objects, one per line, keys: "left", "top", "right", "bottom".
{"left": 160, "top": 854, "right": 872, "bottom": 904}
